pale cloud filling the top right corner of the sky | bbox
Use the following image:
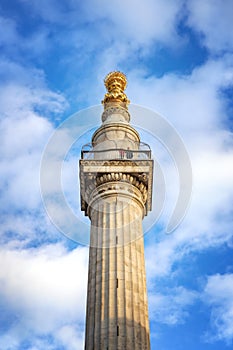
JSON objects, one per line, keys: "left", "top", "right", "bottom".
{"left": 187, "top": 0, "right": 233, "bottom": 52}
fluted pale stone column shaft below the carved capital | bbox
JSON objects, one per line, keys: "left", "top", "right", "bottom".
{"left": 85, "top": 183, "right": 150, "bottom": 350}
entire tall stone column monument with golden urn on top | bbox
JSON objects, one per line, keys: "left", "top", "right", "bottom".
{"left": 80, "top": 72, "right": 153, "bottom": 350}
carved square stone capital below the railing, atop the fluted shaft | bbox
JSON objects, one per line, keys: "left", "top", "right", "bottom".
{"left": 80, "top": 160, "right": 153, "bottom": 215}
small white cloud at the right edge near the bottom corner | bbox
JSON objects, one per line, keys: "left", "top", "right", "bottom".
{"left": 203, "top": 274, "right": 233, "bottom": 344}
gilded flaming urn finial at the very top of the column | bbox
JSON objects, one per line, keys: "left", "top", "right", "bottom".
{"left": 102, "top": 72, "right": 130, "bottom": 109}
